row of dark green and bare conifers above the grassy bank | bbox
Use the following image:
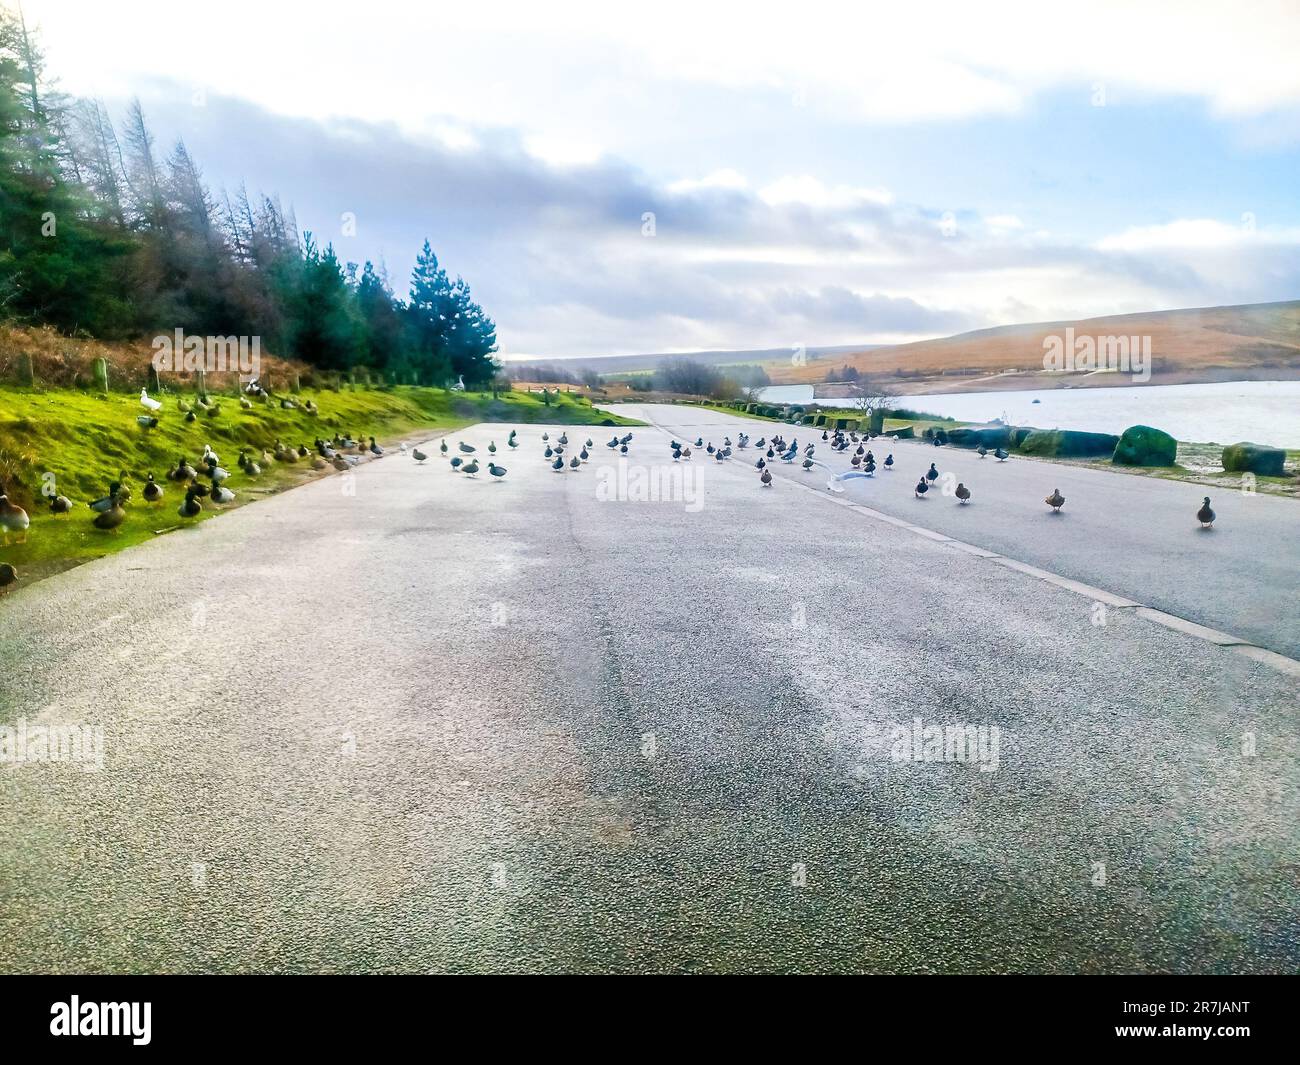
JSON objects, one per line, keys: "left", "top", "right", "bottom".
{"left": 0, "top": 8, "right": 498, "bottom": 388}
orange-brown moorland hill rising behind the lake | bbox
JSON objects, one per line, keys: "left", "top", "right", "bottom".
{"left": 766, "top": 300, "right": 1300, "bottom": 395}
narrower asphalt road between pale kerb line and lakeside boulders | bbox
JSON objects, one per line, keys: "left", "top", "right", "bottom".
{"left": 627, "top": 406, "right": 1300, "bottom": 659}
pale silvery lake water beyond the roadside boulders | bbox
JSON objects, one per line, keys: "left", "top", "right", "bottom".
{"left": 763, "top": 381, "right": 1300, "bottom": 447}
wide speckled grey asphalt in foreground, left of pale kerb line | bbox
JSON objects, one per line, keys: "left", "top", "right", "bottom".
{"left": 0, "top": 413, "right": 1300, "bottom": 971}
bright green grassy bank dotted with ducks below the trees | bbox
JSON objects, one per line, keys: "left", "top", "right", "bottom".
{"left": 0, "top": 386, "right": 640, "bottom": 594}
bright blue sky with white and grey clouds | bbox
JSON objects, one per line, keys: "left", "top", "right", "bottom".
{"left": 23, "top": 0, "right": 1300, "bottom": 358}
